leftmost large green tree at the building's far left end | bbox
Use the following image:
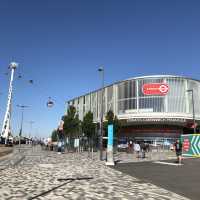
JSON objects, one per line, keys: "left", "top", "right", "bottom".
{"left": 63, "top": 106, "right": 80, "bottom": 138}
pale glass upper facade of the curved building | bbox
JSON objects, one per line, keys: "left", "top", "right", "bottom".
{"left": 68, "top": 76, "right": 200, "bottom": 122}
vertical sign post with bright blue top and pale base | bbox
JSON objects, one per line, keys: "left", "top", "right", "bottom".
{"left": 106, "top": 124, "right": 115, "bottom": 166}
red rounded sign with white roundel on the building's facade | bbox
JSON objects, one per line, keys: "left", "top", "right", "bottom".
{"left": 142, "top": 83, "right": 169, "bottom": 95}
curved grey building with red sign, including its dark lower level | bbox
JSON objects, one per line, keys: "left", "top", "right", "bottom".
{"left": 68, "top": 75, "right": 200, "bottom": 145}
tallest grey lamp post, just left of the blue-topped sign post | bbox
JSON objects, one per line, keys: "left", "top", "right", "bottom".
{"left": 98, "top": 66, "right": 104, "bottom": 160}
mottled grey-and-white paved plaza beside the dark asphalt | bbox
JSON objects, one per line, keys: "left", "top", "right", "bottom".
{"left": 0, "top": 146, "right": 191, "bottom": 200}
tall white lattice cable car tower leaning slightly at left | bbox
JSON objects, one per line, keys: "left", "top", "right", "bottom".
{"left": 1, "top": 62, "right": 18, "bottom": 139}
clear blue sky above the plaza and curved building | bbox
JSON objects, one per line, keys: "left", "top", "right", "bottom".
{"left": 0, "top": 0, "right": 200, "bottom": 137}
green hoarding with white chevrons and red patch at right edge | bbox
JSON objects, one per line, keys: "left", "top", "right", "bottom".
{"left": 181, "top": 134, "right": 200, "bottom": 157}
